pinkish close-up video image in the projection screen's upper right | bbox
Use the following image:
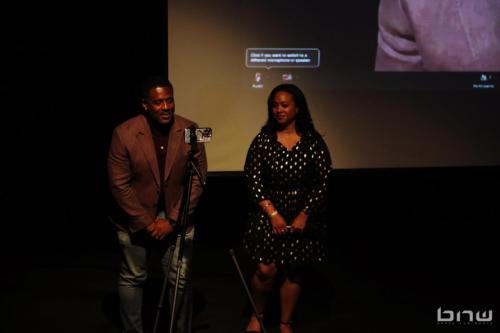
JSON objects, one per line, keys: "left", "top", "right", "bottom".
{"left": 375, "top": 0, "right": 500, "bottom": 72}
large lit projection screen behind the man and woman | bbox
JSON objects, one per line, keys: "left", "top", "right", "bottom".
{"left": 168, "top": 0, "right": 500, "bottom": 171}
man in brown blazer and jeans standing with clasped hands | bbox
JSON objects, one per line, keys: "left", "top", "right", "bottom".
{"left": 108, "top": 78, "right": 207, "bottom": 333}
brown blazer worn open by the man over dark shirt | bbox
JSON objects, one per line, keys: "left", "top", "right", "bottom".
{"left": 108, "top": 115, "right": 207, "bottom": 232}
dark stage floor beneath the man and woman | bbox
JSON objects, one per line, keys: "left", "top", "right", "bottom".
{"left": 1, "top": 228, "right": 499, "bottom": 333}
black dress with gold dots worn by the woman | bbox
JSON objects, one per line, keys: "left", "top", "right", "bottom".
{"left": 243, "top": 132, "right": 332, "bottom": 265}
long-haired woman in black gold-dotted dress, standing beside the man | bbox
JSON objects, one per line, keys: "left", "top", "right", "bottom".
{"left": 244, "top": 84, "right": 332, "bottom": 333}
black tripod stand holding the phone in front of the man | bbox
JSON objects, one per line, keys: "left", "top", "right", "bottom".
{"left": 153, "top": 129, "right": 206, "bottom": 333}
